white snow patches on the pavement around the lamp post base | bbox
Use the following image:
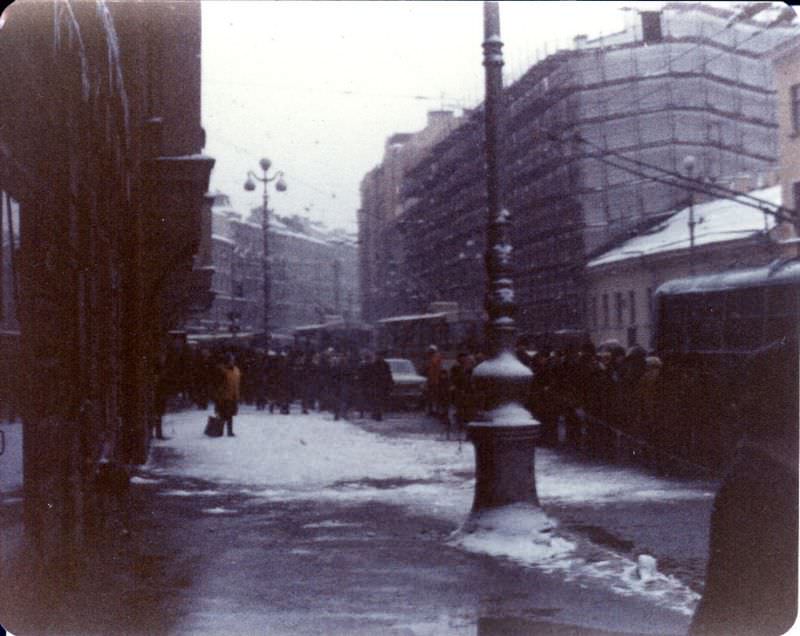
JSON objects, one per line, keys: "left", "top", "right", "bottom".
{"left": 147, "top": 409, "right": 713, "bottom": 614}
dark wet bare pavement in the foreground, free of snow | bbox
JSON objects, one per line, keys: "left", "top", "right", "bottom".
{"left": 3, "top": 412, "right": 707, "bottom": 636}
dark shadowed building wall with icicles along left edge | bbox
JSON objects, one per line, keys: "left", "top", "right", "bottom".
{"left": 0, "top": 2, "right": 213, "bottom": 559}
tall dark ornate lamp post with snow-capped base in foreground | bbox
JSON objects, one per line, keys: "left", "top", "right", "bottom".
{"left": 469, "top": 2, "right": 540, "bottom": 523}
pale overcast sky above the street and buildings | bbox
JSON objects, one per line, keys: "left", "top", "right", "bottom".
{"left": 203, "top": 0, "right": 676, "bottom": 230}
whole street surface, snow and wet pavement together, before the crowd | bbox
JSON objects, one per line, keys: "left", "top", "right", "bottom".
{"left": 83, "top": 408, "right": 715, "bottom": 634}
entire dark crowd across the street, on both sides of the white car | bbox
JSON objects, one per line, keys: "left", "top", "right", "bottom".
{"left": 154, "top": 341, "right": 752, "bottom": 470}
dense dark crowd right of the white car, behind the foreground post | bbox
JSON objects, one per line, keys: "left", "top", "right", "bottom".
{"left": 424, "top": 340, "right": 742, "bottom": 471}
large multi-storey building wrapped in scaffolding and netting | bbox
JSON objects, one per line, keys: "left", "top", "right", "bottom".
{"left": 390, "top": 3, "right": 798, "bottom": 332}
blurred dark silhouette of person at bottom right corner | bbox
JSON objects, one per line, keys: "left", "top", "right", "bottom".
{"left": 689, "top": 339, "right": 798, "bottom": 636}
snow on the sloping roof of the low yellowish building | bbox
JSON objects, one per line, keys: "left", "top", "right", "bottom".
{"left": 587, "top": 186, "right": 781, "bottom": 267}
